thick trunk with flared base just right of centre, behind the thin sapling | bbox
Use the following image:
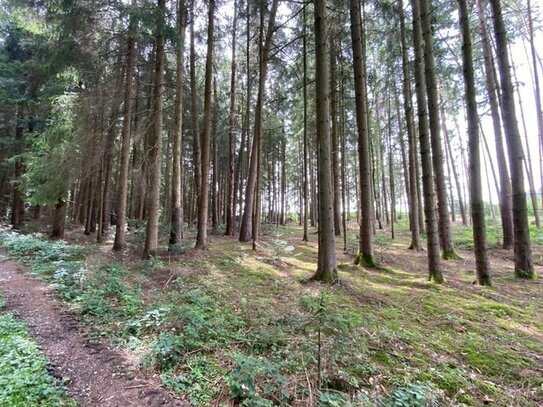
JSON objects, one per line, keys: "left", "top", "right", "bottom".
{"left": 312, "top": 0, "right": 338, "bottom": 283}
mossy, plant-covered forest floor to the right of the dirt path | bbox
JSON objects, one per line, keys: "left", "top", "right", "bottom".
{"left": 0, "top": 222, "right": 543, "bottom": 407}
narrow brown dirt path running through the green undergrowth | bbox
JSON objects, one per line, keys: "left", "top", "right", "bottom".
{"left": 0, "top": 252, "right": 187, "bottom": 407}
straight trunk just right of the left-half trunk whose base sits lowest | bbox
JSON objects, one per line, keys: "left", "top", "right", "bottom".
{"left": 168, "top": 0, "right": 186, "bottom": 251}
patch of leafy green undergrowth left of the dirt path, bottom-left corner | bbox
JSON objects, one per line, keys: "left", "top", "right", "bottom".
{"left": 0, "top": 300, "right": 76, "bottom": 407}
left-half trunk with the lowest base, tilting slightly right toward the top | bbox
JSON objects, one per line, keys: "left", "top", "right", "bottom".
{"left": 143, "top": 0, "right": 166, "bottom": 258}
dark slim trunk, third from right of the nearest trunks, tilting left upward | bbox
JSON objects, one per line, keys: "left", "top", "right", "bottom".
{"left": 411, "top": 0, "right": 443, "bottom": 284}
